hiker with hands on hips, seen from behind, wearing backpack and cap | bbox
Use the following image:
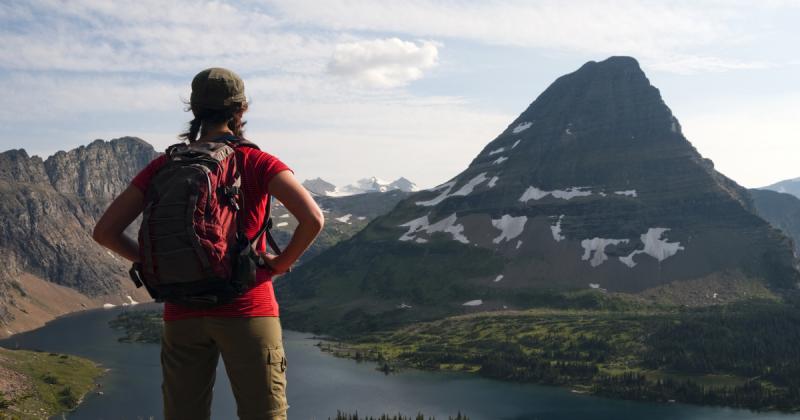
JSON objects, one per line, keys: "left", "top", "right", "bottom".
{"left": 93, "top": 68, "right": 324, "bottom": 420}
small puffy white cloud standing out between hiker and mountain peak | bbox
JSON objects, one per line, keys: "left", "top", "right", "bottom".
{"left": 328, "top": 38, "right": 439, "bottom": 88}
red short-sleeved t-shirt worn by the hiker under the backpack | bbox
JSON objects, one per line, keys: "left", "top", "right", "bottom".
{"left": 131, "top": 143, "right": 291, "bottom": 321}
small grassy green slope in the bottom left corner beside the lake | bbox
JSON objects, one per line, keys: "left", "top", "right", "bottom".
{"left": 0, "top": 348, "right": 103, "bottom": 419}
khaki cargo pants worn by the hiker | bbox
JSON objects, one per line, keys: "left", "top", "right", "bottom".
{"left": 161, "top": 317, "right": 288, "bottom": 420}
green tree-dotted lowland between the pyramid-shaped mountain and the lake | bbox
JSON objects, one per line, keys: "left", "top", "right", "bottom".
{"left": 321, "top": 301, "right": 800, "bottom": 411}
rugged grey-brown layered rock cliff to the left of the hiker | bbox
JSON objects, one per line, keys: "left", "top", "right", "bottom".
{"left": 0, "top": 138, "right": 157, "bottom": 334}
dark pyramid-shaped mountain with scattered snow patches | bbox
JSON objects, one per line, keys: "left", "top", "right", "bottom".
{"left": 279, "top": 57, "right": 798, "bottom": 330}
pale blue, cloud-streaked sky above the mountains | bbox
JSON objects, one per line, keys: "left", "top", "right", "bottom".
{"left": 0, "top": 0, "right": 800, "bottom": 188}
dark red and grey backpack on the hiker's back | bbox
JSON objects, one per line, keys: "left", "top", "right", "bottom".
{"left": 130, "top": 136, "right": 281, "bottom": 309}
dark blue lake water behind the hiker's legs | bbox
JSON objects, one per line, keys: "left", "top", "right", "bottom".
{"left": 0, "top": 305, "right": 800, "bottom": 420}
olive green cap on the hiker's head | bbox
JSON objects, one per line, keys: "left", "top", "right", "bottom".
{"left": 189, "top": 67, "right": 247, "bottom": 111}
